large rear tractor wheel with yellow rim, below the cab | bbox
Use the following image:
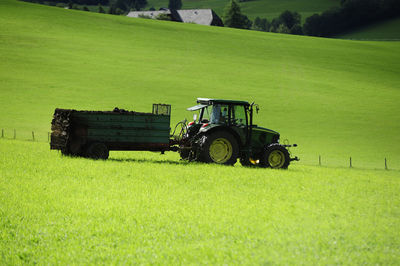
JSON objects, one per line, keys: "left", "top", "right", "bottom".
{"left": 200, "top": 131, "right": 239, "bottom": 165}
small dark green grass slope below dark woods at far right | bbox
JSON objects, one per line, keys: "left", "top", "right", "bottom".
{"left": 337, "top": 18, "right": 400, "bottom": 41}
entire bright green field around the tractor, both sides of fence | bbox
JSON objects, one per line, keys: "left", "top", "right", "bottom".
{"left": 0, "top": 0, "right": 400, "bottom": 264}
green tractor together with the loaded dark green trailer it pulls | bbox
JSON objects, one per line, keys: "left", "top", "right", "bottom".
{"left": 50, "top": 98, "right": 298, "bottom": 168}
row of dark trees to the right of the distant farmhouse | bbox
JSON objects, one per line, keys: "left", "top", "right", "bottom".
{"left": 223, "top": 0, "right": 400, "bottom": 37}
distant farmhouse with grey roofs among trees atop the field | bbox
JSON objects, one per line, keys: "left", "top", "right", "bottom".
{"left": 127, "top": 9, "right": 224, "bottom": 26}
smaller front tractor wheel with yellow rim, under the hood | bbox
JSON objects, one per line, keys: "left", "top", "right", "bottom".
{"left": 260, "top": 143, "right": 290, "bottom": 169}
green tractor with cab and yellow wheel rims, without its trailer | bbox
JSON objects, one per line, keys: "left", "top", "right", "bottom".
{"left": 179, "top": 98, "right": 299, "bottom": 169}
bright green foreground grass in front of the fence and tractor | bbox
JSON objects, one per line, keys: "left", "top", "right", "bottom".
{"left": 0, "top": 140, "right": 400, "bottom": 265}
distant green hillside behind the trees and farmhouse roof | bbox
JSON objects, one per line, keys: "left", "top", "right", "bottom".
{"left": 148, "top": 0, "right": 340, "bottom": 20}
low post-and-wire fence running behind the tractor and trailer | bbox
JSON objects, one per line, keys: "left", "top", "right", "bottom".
{"left": 0, "top": 129, "right": 398, "bottom": 170}
